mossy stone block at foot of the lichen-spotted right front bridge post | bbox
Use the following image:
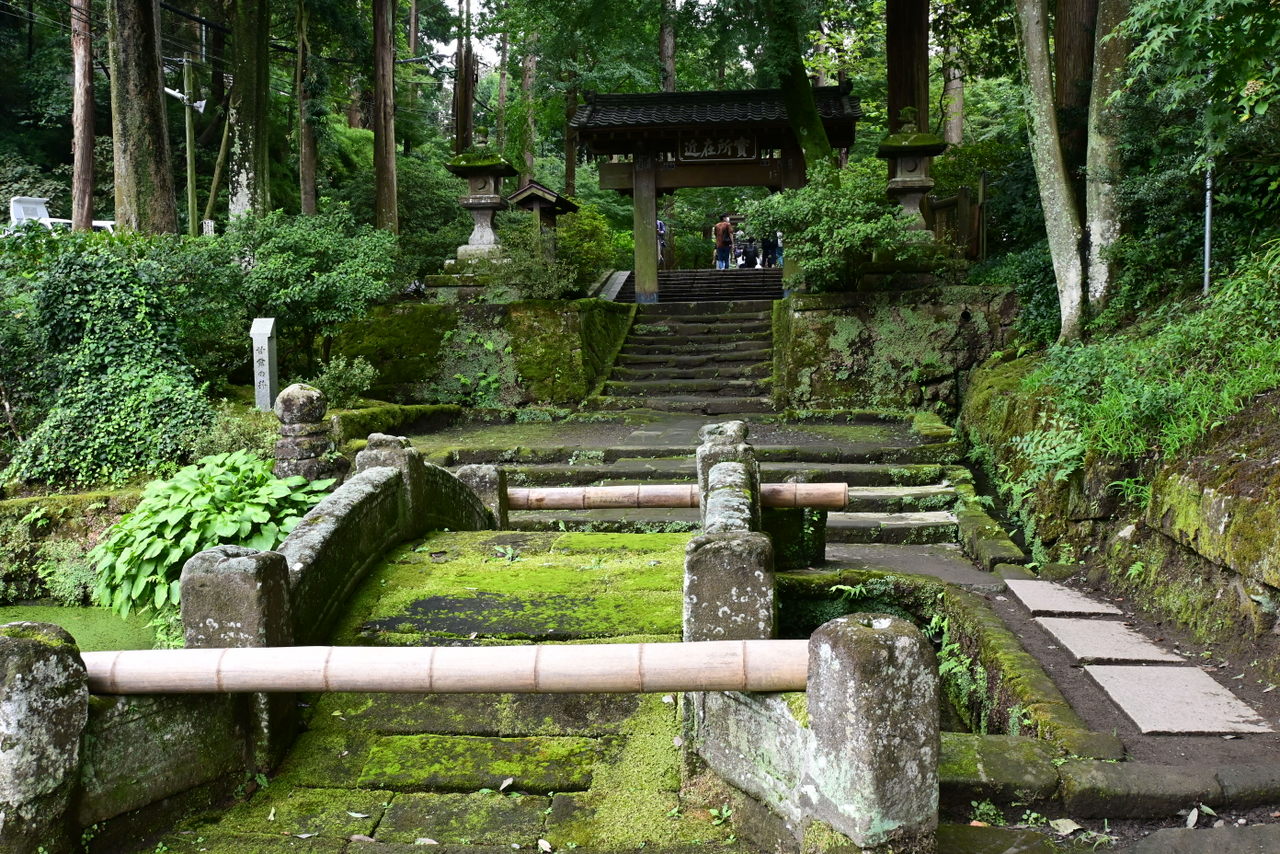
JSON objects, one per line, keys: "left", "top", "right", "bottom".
{"left": 938, "top": 732, "right": 1057, "bottom": 807}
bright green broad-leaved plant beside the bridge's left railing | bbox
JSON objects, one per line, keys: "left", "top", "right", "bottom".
{"left": 90, "top": 451, "right": 333, "bottom": 616}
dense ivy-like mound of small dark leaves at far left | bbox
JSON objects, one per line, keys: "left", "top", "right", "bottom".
{"left": 4, "top": 236, "right": 212, "bottom": 483}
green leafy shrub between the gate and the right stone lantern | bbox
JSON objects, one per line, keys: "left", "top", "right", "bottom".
{"left": 745, "top": 160, "right": 919, "bottom": 291}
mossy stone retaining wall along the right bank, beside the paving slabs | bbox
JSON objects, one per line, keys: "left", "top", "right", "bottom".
{"left": 960, "top": 357, "right": 1280, "bottom": 679}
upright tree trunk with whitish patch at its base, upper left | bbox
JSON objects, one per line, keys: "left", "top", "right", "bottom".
{"left": 228, "top": 0, "right": 271, "bottom": 216}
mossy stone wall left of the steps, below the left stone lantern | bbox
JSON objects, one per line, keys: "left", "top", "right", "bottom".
{"left": 334, "top": 300, "right": 635, "bottom": 408}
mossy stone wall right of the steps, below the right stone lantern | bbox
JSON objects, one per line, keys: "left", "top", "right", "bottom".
{"left": 773, "top": 287, "right": 1014, "bottom": 415}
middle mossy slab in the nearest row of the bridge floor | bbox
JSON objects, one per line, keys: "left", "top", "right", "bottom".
{"left": 378, "top": 791, "right": 550, "bottom": 850}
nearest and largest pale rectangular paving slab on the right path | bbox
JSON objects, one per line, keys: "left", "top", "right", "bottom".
{"left": 1085, "top": 665, "right": 1272, "bottom": 735}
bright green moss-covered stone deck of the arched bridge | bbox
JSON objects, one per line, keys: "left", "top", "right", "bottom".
{"left": 165, "top": 531, "right": 732, "bottom": 854}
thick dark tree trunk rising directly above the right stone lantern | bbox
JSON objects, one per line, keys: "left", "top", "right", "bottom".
{"left": 884, "top": 0, "right": 929, "bottom": 133}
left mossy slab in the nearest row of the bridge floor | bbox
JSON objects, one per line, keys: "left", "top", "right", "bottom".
{"left": 218, "top": 781, "right": 394, "bottom": 839}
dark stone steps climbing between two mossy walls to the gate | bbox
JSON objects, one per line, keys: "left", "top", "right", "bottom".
{"left": 595, "top": 300, "right": 773, "bottom": 415}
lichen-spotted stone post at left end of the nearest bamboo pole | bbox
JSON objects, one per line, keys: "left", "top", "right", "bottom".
{"left": 0, "top": 622, "right": 88, "bottom": 854}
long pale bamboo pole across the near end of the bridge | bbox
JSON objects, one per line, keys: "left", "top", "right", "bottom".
{"left": 81, "top": 640, "right": 809, "bottom": 694}
